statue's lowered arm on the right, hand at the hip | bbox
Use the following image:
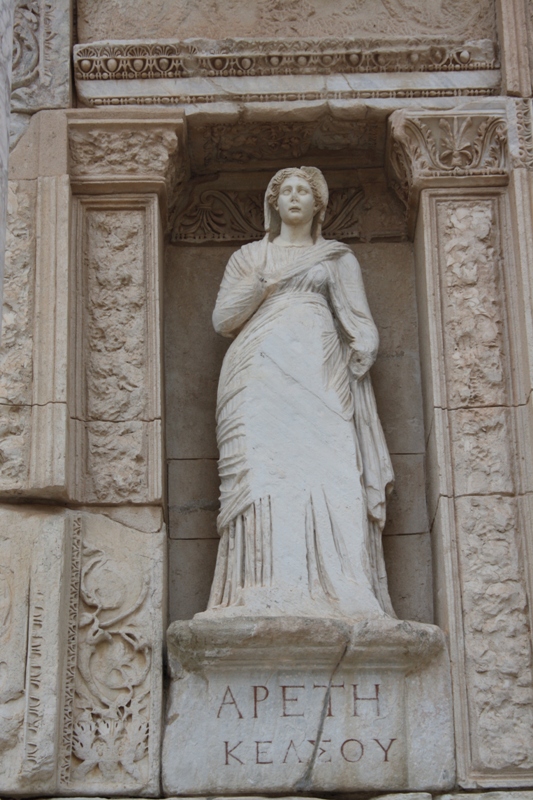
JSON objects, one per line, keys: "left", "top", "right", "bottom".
{"left": 330, "top": 252, "right": 379, "bottom": 378}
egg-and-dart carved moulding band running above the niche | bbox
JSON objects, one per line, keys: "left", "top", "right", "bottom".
{"left": 74, "top": 37, "right": 499, "bottom": 81}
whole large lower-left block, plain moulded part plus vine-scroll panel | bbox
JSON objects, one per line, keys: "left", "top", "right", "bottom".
{"left": 0, "top": 505, "right": 165, "bottom": 795}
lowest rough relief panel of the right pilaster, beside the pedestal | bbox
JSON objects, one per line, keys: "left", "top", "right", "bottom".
{"left": 456, "top": 495, "right": 533, "bottom": 771}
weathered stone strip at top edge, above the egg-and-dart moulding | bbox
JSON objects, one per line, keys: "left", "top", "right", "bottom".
{"left": 78, "top": 0, "right": 496, "bottom": 42}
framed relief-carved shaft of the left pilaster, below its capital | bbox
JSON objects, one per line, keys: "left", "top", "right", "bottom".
{"left": 73, "top": 195, "right": 161, "bottom": 502}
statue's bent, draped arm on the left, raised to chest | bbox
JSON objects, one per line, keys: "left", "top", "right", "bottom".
{"left": 213, "top": 248, "right": 267, "bottom": 338}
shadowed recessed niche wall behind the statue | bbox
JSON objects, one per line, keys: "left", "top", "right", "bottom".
{"left": 164, "top": 123, "right": 433, "bottom": 622}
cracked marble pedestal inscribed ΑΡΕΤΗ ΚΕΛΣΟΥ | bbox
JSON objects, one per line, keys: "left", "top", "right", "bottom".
{"left": 163, "top": 617, "right": 455, "bottom": 795}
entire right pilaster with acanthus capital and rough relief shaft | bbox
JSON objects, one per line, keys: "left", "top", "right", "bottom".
{"left": 390, "top": 108, "right": 533, "bottom": 788}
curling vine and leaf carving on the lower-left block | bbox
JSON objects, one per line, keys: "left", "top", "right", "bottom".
{"left": 73, "top": 548, "right": 152, "bottom": 782}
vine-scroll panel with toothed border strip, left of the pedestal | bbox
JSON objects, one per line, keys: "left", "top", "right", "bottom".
{"left": 61, "top": 514, "right": 165, "bottom": 795}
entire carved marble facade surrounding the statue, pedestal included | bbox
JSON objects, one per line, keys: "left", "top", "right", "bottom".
{"left": 0, "top": 0, "right": 533, "bottom": 800}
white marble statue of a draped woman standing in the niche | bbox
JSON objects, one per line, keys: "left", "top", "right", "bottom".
{"left": 204, "top": 167, "right": 394, "bottom": 619}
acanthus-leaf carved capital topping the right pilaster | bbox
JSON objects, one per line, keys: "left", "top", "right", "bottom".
{"left": 387, "top": 110, "right": 509, "bottom": 235}
